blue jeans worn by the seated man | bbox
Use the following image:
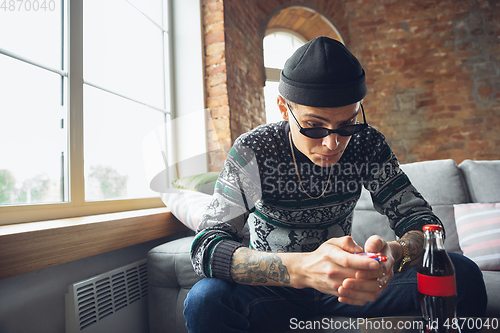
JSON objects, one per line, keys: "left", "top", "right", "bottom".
{"left": 184, "top": 253, "right": 487, "bottom": 333}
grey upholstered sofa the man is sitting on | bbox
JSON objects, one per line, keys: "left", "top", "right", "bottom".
{"left": 148, "top": 160, "right": 500, "bottom": 333}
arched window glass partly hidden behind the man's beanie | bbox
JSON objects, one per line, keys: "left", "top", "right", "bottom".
{"left": 264, "top": 31, "right": 306, "bottom": 123}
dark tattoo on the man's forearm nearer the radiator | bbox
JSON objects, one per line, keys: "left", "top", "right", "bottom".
{"left": 231, "top": 249, "right": 290, "bottom": 284}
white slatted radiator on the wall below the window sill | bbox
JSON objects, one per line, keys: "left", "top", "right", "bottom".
{"left": 66, "top": 259, "right": 149, "bottom": 333}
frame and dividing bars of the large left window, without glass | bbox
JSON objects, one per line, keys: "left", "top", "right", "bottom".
{"left": 0, "top": 0, "right": 178, "bottom": 225}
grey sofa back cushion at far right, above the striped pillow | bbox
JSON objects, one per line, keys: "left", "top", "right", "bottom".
{"left": 459, "top": 160, "right": 500, "bottom": 202}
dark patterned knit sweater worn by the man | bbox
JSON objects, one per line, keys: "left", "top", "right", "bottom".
{"left": 191, "top": 121, "right": 441, "bottom": 281}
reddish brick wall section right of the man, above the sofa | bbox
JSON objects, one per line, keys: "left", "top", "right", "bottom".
{"left": 346, "top": 0, "right": 500, "bottom": 163}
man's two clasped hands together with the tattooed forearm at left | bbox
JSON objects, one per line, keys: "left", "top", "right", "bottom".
{"left": 231, "top": 231, "right": 421, "bottom": 305}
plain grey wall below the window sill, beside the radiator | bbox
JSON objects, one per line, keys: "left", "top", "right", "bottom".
{"left": 0, "top": 231, "right": 189, "bottom": 333}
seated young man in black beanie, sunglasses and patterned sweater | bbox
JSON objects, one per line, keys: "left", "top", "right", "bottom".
{"left": 184, "top": 37, "right": 486, "bottom": 332}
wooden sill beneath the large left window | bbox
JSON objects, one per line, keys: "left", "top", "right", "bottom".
{"left": 0, "top": 208, "right": 188, "bottom": 280}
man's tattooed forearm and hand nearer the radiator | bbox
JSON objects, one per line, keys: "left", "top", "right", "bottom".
{"left": 231, "top": 236, "right": 380, "bottom": 304}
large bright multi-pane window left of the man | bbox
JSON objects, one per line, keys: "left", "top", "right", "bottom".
{"left": 0, "top": 0, "right": 170, "bottom": 224}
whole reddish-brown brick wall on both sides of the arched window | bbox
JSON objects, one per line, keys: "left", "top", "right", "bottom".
{"left": 202, "top": 0, "right": 500, "bottom": 170}
